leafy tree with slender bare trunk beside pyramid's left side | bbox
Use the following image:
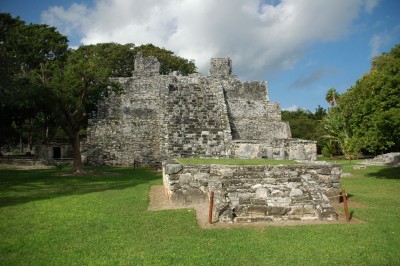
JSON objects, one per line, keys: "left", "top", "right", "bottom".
{"left": 37, "top": 43, "right": 198, "bottom": 172}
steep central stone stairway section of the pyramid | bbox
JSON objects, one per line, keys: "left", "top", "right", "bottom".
{"left": 162, "top": 75, "right": 232, "bottom": 158}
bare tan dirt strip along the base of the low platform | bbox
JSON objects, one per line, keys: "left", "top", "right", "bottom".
{"left": 148, "top": 185, "right": 365, "bottom": 229}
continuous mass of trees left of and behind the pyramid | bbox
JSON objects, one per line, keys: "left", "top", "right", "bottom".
{"left": 0, "top": 13, "right": 196, "bottom": 171}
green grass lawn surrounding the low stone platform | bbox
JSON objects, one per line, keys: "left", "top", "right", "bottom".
{"left": 0, "top": 162, "right": 400, "bottom": 265}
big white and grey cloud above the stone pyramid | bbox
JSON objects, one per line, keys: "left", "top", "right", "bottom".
{"left": 42, "top": 0, "right": 378, "bottom": 79}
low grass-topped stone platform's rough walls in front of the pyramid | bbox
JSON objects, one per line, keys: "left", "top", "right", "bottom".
{"left": 163, "top": 161, "right": 341, "bottom": 222}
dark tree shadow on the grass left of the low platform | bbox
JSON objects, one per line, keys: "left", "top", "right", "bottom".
{"left": 0, "top": 167, "right": 161, "bottom": 207}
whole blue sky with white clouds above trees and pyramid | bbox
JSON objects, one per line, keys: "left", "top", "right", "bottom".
{"left": 0, "top": 0, "right": 400, "bottom": 111}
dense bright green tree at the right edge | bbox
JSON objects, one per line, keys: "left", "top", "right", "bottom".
{"left": 324, "top": 45, "right": 400, "bottom": 154}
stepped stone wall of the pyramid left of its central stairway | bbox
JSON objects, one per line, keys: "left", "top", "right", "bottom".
{"left": 84, "top": 75, "right": 170, "bottom": 165}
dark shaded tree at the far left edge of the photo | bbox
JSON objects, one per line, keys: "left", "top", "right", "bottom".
{"left": 0, "top": 13, "right": 68, "bottom": 148}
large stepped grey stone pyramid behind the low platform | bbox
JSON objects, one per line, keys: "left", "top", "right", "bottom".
{"left": 84, "top": 54, "right": 316, "bottom": 165}
